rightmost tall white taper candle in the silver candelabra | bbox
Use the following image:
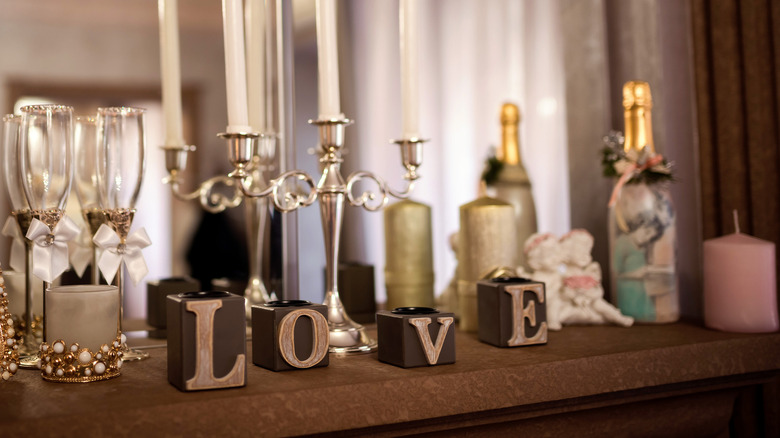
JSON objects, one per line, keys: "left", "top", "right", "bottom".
{"left": 399, "top": 0, "right": 420, "bottom": 139}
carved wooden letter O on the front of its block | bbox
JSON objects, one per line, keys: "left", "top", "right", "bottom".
{"left": 279, "top": 309, "right": 328, "bottom": 368}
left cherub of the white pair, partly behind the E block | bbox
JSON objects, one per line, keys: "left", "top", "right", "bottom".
{"left": 518, "top": 233, "right": 562, "bottom": 330}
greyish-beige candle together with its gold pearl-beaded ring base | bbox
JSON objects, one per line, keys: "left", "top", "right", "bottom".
{"left": 40, "top": 285, "right": 124, "bottom": 383}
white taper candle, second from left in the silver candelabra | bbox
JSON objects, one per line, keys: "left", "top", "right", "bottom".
{"left": 222, "top": 0, "right": 252, "bottom": 133}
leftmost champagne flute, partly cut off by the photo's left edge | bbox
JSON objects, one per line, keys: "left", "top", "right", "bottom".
{"left": 3, "top": 114, "right": 40, "bottom": 362}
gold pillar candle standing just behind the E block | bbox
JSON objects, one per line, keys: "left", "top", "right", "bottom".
{"left": 458, "top": 197, "right": 517, "bottom": 332}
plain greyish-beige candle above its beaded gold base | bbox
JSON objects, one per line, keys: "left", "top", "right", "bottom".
{"left": 44, "top": 284, "right": 119, "bottom": 352}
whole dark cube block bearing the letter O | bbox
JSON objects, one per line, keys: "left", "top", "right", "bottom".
{"left": 252, "top": 300, "right": 330, "bottom": 371}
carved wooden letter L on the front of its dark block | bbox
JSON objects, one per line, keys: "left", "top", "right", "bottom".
{"left": 185, "top": 300, "right": 246, "bottom": 391}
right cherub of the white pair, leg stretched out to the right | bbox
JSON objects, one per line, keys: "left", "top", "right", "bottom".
{"left": 559, "top": 229, "right": 634, "bottom": 327}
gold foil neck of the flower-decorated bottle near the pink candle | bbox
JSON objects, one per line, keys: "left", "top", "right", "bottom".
{"left": 623, "top": 81, "right": 655, "bottom": 154}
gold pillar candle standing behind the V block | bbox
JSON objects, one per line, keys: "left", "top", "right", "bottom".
{"left": 384, "top": 200, "right": 434, "bottom": 310}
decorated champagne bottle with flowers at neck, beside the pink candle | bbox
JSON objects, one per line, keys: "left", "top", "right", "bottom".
{"left": 603, "top": 81, "right": 680, "bottom": 323}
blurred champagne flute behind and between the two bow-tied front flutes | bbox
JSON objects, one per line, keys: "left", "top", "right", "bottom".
{"left": 73, "top": 116, "right": 106, "bottom": 284}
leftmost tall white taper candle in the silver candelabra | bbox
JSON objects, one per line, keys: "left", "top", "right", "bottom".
{"left": 157, "top": 0, "right": 184, "bottom": 146}
